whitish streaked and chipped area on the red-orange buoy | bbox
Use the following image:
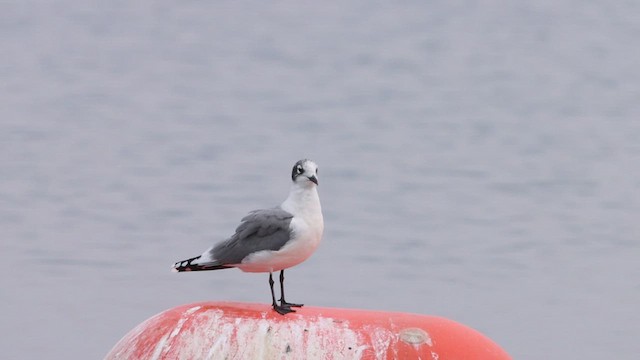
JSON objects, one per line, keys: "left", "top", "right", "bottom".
{"left": 153, "top": 309, "right": 372, "bottom": 360}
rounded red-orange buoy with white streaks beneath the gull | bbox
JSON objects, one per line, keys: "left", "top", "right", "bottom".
{"left": 105, "top": 302, "right": 511, "bottom": 360}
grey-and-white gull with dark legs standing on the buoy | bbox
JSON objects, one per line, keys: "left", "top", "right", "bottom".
{"left": 172, "top": 159, "right": 324, "bottom": 315}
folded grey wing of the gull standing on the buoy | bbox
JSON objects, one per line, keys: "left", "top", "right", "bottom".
{"left": 210, "top": 208, "right": 293, "bottom": 265}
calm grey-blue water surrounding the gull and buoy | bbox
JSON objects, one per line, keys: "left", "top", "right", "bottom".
{"left": 0, "top": 0, "right": 640, "bottom": 359}
